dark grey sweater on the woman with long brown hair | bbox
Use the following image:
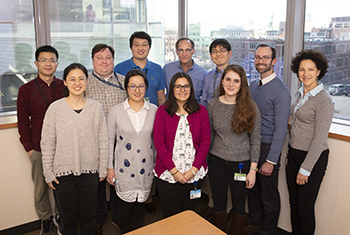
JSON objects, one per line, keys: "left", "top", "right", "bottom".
{"left": 207, "top": 97, "right": 261, "bottom": 163}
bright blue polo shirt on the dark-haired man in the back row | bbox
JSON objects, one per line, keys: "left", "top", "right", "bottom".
{"left": 114, "top": 58, "right": 166, "bottom": 106}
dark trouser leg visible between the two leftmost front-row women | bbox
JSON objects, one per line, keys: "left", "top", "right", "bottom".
{"left": 96, "top": 180, "right": 108, "bottom": 225}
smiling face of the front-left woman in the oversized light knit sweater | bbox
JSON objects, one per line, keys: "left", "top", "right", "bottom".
{"left": 63, "top": 69, "right": 87, "bottom": 96}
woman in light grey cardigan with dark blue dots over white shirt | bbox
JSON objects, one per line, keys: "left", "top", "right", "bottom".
{"left": 107, "top": 70, "right": 157, "bottom": 233}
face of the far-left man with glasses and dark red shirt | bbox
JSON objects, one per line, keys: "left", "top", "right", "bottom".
{"left": 35, "top": 52, "right": 58, "bottom": 79}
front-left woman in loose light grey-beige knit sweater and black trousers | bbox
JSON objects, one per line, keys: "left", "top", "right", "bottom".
{"left": 41, "top": 63, "right": 108, "bottom": 235}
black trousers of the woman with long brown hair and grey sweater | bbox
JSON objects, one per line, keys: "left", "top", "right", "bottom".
{"left": 208, "top": 155, "right": 250, "bottom": 215}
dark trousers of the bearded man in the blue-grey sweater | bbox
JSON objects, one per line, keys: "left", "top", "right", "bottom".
{"left": 247, "top": 143, "right": 281, "bottom": 235}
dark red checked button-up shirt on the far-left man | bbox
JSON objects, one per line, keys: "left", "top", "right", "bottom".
{"left": 17, "top": 75, "right": 64, "bottom": 152}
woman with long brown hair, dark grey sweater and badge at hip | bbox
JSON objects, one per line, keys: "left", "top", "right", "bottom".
{"left": 207, "top": 64, "right": 261, "bottom": 234}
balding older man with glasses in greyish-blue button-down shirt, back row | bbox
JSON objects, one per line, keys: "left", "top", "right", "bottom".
{"left": 163, "top": 37, "right": 207, "bottom": 102}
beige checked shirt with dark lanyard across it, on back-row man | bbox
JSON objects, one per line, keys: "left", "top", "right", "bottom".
{"left": 85, "top": 73, "right": 127, "bottom": 117}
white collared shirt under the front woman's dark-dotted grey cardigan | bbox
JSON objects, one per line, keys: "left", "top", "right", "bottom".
{"left": 124, "top": 98, "right": 150, "bottom": 134}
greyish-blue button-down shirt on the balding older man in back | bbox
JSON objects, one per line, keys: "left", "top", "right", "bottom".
{"left": 163, "top": 60, "right": 207, "bottom": 102}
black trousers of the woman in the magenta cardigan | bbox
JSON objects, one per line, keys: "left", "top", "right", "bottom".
{"left": 155, "top": 177, "right": 203, "bottom": 218}
